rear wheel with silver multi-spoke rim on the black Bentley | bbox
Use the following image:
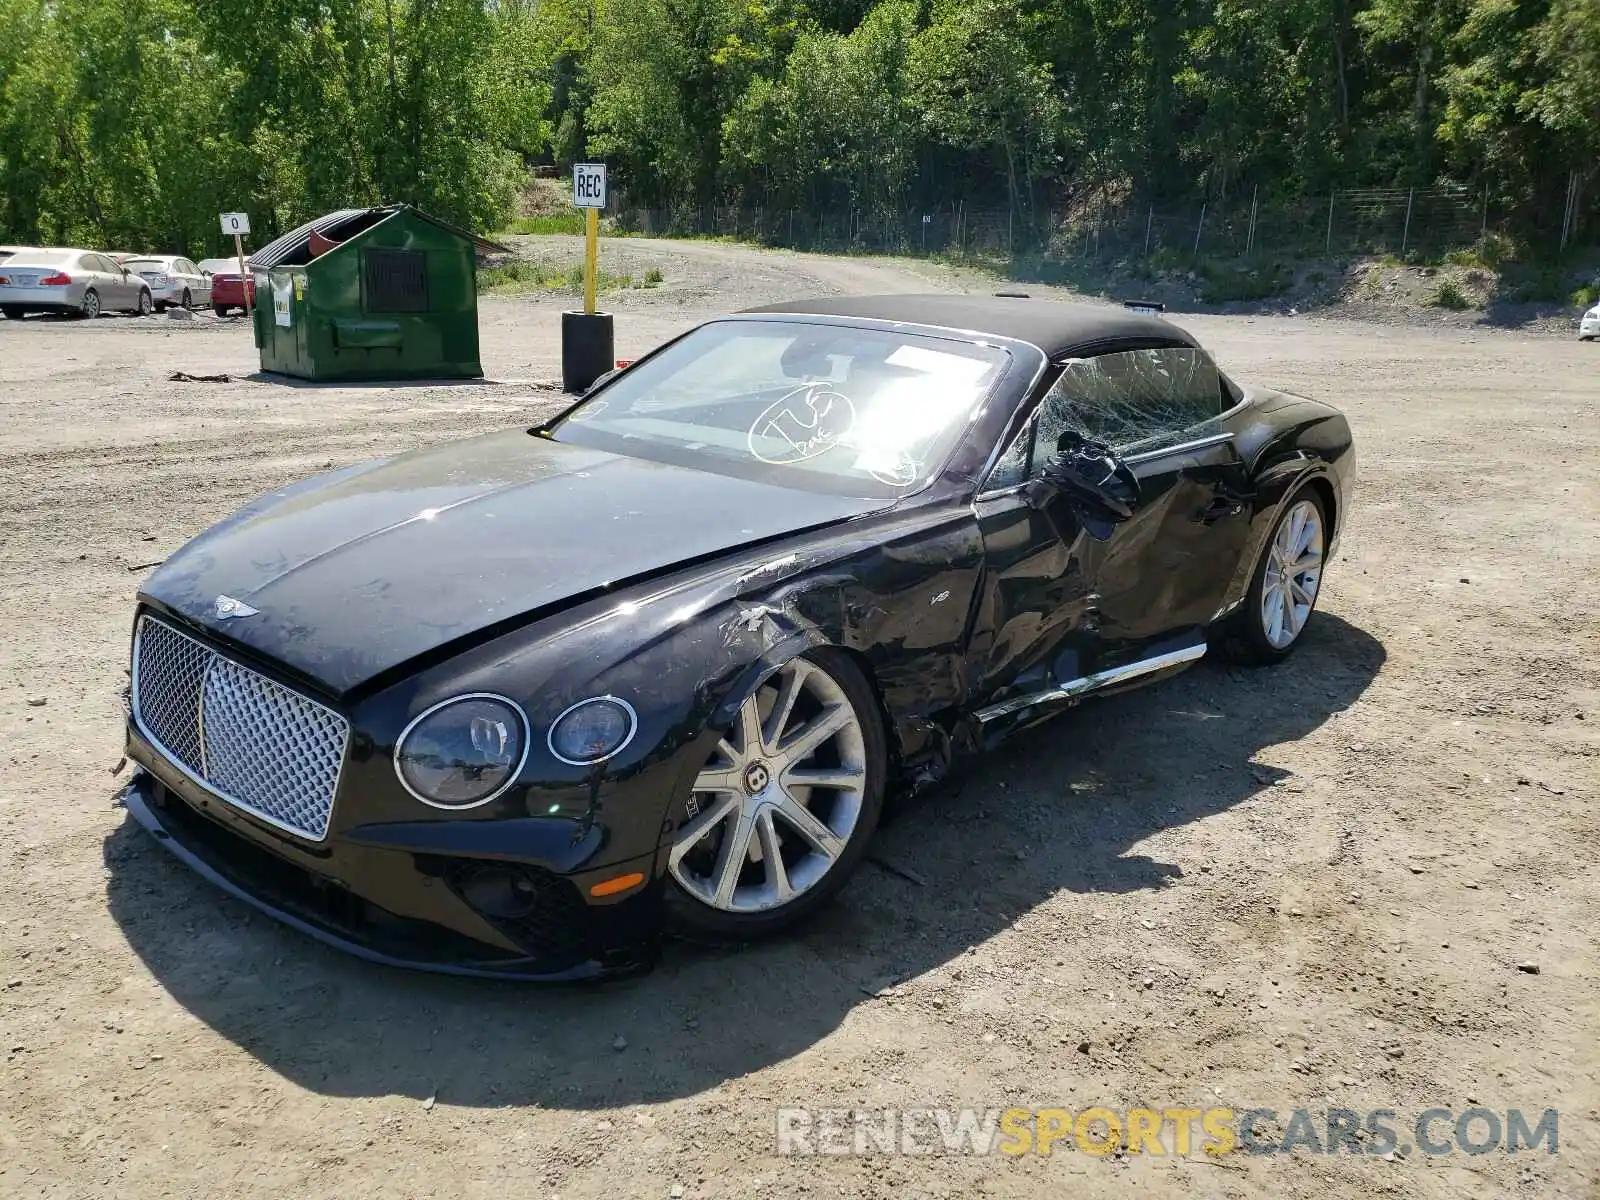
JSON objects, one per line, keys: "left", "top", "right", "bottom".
{"left": 1230, "top": 488, "right": 1328, "bottom": 662}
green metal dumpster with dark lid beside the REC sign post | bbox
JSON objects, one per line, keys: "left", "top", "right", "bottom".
{"left": 250, "top": 205, "right": 502, "bottom": 379}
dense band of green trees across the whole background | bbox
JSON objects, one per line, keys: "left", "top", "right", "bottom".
{"left": 0, "top": 0, "right": 1600, "bottom": 254}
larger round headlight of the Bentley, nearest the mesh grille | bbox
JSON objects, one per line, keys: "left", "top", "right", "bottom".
{"left": 395, "top": 694, "right": 528, "bottom": 808}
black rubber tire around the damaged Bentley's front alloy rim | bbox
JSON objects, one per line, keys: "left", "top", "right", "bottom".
{"left": 666, "top": 648, "right": 888, "bottom": 944}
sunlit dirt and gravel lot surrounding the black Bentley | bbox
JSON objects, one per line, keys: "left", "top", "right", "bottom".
{"left": 0, "top": 242, "right": 1600, "bottom": 1200}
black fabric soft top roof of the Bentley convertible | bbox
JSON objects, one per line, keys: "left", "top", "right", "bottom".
{"left": 747, "top": 293, "right": 1198, "bottom": 358}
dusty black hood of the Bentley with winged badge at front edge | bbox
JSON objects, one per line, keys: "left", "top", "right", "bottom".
{"left": 144, "top": 429, "right": 886, "bottom": 694}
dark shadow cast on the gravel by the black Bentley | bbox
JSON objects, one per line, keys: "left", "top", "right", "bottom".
{"left": 104, "top": 613, "right": 1384, "bottom": 1110}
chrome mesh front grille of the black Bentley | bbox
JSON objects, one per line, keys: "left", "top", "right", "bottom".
{"left": 133, "top": 616, "right": 350, "bottom": 842}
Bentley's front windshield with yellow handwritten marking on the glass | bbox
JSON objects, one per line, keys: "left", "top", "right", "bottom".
{"left": 554, "top": 322, "right": 1010, "bottom": 498}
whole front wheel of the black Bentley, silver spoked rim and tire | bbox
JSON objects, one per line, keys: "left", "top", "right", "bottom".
{"left": 667, "top": 651, "right": 886, "bottom": 941}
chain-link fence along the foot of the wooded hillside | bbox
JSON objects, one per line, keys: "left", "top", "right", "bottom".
{"left": 614, "top": 187, "right": 1594, "bottom": 262}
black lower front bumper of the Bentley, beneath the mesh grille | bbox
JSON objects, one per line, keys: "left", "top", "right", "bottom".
{"left": 122, "top": 768, "right": 661, "bottom": 982}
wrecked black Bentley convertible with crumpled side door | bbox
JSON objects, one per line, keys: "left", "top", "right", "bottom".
{"left": 125, "top": 296, "right": 1352, "bottom": 979}
